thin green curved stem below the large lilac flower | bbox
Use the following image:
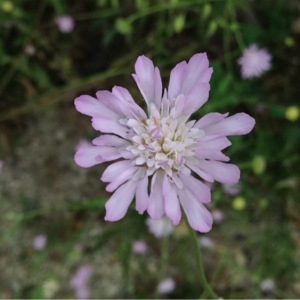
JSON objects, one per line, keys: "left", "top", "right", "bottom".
{"left": 185, "top": 218, "right": 220, "bottom": 299}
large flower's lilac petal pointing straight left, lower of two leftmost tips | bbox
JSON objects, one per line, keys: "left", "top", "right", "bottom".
{"left": 74, "top": 146, "right": 121, "bottom": 168}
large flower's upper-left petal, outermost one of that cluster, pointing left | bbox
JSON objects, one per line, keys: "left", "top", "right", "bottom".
{"left": 74, "top": 95, "right": 120, "bottom": 120}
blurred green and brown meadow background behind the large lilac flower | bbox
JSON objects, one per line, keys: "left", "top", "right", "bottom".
{"left": 0, "top": 0, "right": 300, "bottom": 299}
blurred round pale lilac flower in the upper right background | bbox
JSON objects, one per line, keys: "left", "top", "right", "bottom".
{"left": 238, "top": 45, "right": 272, "bottom": 78}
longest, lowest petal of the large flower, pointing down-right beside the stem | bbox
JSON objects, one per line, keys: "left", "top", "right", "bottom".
{"left": 178, "top": 189, "right": 213, "bottom": 232}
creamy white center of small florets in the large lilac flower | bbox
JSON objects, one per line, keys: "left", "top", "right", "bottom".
{"left": 122, "top": 105, "right": 204, "bottom": 177}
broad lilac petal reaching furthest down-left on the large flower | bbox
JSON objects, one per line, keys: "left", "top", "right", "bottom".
{"left": 105, "top": 181, "right": 136, "bottom": 221}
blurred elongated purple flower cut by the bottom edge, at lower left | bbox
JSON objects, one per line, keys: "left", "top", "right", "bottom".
{"left": 70, "top": 265, "right": 92, "bottom": 299}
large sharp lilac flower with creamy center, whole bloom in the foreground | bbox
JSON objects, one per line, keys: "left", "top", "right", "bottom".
{"left": 75, "top": 53, "right": 255, "bottom": 232}
